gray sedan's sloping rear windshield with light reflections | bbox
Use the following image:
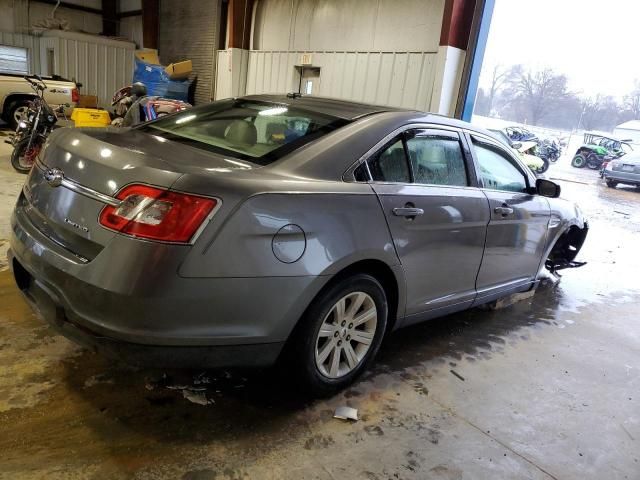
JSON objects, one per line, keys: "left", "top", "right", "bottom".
{"left": 139, "top": 99, "right": 348, "bottom": 165}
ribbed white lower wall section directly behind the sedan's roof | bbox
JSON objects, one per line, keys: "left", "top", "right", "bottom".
{"left": 242, "top": 50, "right": 437, "bottom": 110}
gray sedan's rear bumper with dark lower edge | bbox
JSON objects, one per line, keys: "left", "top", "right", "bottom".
{"left": 9, "top": 205, "right": 324, "bottom": 367}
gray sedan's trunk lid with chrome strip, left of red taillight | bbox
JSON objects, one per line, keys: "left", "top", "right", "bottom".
{"left": 20, "top": 128, "right": 252, "bottom": 261}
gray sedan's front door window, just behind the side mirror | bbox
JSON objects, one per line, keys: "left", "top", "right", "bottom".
{"left": 473, "top": 140, "right": 527, "bottom": 192}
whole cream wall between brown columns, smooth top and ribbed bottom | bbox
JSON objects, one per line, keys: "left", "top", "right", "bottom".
{"left": 240, "top": 0, "right": 445, "bottom": 110}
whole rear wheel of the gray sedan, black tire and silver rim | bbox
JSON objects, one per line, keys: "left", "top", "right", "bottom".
{"left": 290, "top": 274, "right": 388, "bottom": 396}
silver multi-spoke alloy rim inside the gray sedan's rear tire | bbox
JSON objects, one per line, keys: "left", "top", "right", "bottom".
{"left": 315, "top": 292, "right": 378, "bottom": 378}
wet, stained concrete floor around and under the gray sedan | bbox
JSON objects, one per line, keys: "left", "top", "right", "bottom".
{"left": 0, "top": 133, "right": 640, "bottom": 480}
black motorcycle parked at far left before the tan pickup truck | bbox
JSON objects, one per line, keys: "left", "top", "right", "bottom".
{"left": 6, "top": 75, "right": 68, "bottom": 173}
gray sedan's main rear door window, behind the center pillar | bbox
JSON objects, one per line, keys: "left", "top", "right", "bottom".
{"left": 407, "top": 130, "right": 469, "bottom": 187}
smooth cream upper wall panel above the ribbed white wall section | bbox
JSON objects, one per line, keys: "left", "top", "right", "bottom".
{"left": 253, "top": 0, "right": 444, "bottom": 52}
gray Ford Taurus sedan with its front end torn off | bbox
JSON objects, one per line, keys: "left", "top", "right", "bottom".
{"left": 9, "top": 95, "right": 588, "bottom": 394}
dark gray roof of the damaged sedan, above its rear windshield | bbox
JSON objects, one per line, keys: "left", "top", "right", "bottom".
{"left": 242, "top": 93, "right": 411, "bottom": 121}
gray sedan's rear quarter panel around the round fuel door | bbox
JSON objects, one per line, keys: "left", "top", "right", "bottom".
{"left": 180, "top": 184, "right": 399, "bottom": 277}
